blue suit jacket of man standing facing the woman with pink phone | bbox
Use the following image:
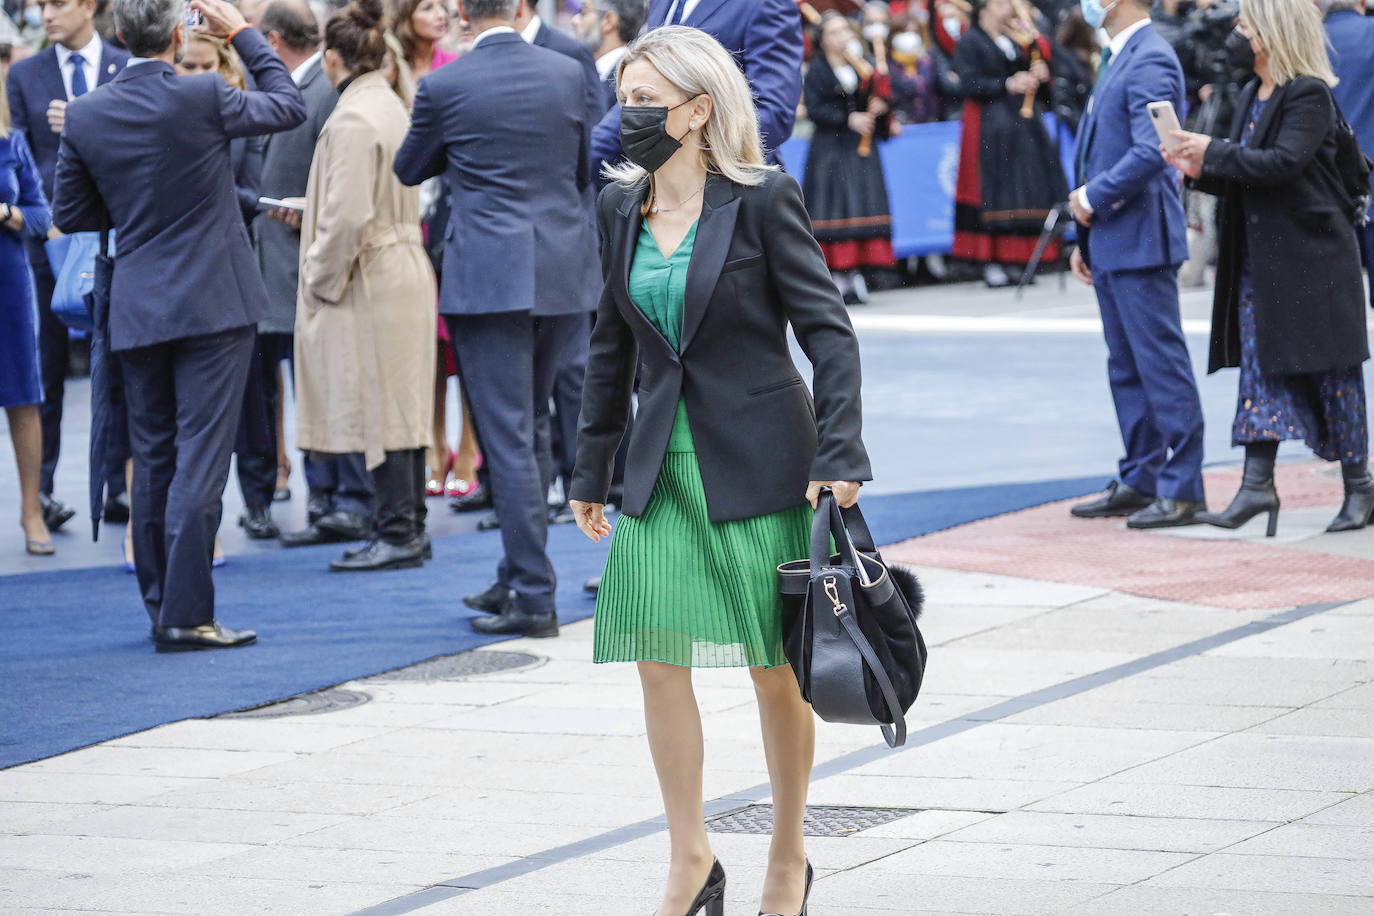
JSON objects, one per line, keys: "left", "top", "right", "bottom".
{"left": 1079, "top": 25, "right": 1189, "bottom": 272}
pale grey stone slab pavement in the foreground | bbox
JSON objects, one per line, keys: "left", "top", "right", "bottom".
{"left": 0, "top": 467, "right": 1374, "bottom": 916}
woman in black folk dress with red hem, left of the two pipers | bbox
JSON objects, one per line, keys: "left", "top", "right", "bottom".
{"left": 801, "top": 12, "right": 900, "bottom": 304}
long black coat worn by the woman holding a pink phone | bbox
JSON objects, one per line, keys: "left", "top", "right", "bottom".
{"left": 1194, "top": 77, "right": 1369, "bottom": 375}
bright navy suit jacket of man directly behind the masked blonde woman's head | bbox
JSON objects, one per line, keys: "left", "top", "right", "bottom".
{"left": 592, "top": 0, "right": 802, "bottom": 176}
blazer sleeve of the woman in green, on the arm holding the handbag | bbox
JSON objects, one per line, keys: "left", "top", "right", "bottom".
{"left": 763, "top": 174, "right": 872, "bottom": 481}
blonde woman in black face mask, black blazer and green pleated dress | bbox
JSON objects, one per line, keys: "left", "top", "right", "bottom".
{"left": 572, "top": 26, "right": 871, "bottom": 916}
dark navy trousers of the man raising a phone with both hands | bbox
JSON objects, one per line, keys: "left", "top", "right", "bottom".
{"left": 120, "top": 325, "right": 254, "bottom": 626}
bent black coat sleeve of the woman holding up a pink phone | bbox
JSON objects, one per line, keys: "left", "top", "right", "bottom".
{"left": 1202, "top": 78, "right": 1334, "bottom": 187}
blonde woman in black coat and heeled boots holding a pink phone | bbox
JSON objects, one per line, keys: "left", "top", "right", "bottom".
{"left": 1165, "top": 0, "right": 1374, "bottom": 536}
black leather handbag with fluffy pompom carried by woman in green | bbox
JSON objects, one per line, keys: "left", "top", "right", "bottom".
{"left": 778, "top": 490, "right": 927, "bottom": 747}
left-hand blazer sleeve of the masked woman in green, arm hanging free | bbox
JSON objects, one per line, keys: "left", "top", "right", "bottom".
{"left": 569, "top": 184, "right": 639, "bottom": 503}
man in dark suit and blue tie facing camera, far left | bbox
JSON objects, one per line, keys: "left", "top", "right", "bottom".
{"left": 8, "top": 0, "right": 129, "bottom": 530}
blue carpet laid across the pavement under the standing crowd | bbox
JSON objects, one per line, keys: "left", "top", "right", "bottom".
{"left": 0, "top": 478, "right": 1103, "bottom": 769}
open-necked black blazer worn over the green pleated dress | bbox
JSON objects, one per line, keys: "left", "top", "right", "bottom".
{"left": 570, "top": 172, "right": 872, "bottom": 522}
